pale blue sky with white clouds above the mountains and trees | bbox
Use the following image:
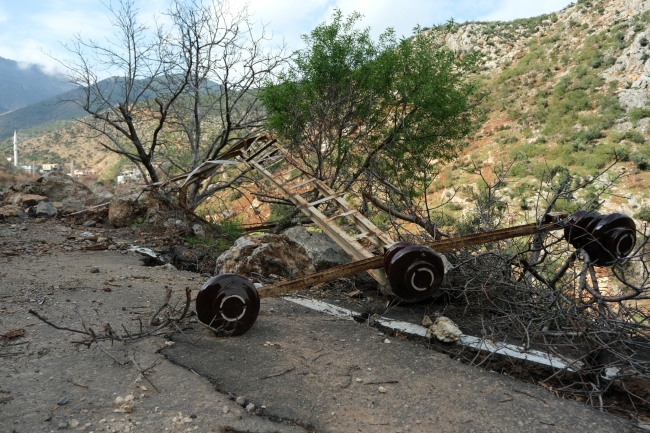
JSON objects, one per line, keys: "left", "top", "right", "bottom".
{"left": 0, "top": 0, "right": 570, "bottom": 72}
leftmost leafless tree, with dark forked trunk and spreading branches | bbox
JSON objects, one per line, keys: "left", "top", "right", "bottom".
{"left": 61, "top": 0, "right": 187, "bottom": 182}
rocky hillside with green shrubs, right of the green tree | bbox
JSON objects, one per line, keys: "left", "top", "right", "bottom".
{"left": 435, "top": 0, "right": 650, "bottom": 221}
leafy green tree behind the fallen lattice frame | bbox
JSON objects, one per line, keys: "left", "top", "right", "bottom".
{"left": 261, "top": 11, "right": 478, "bottom": 238}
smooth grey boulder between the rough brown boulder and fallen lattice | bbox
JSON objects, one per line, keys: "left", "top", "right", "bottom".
{"left": 284, "top": 226, "right": 352, "bottom": 271}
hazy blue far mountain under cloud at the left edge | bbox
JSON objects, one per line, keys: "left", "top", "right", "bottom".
{"left": 0, "top": 57, "right": 72, "bottom": 114}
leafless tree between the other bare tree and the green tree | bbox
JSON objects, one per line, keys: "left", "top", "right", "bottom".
{"left": 162, "top": 0, "right": 285, "bottom": 208}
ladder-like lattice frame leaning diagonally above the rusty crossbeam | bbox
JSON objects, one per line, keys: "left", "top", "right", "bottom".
{"left": 240, "top": 139, "right": 394, "bottom": 292}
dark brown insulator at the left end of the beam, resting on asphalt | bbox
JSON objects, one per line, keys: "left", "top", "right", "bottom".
{"left": 196, "top": 274, "right": 260, "bottom": 335}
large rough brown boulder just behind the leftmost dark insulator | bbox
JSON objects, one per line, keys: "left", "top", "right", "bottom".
{"left": 215, "top": 234, "right": 315, "bottom": 279}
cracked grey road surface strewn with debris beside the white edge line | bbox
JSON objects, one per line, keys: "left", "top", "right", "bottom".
{"left": 0, "top": 219, "right": 636, "bottom": 432}
